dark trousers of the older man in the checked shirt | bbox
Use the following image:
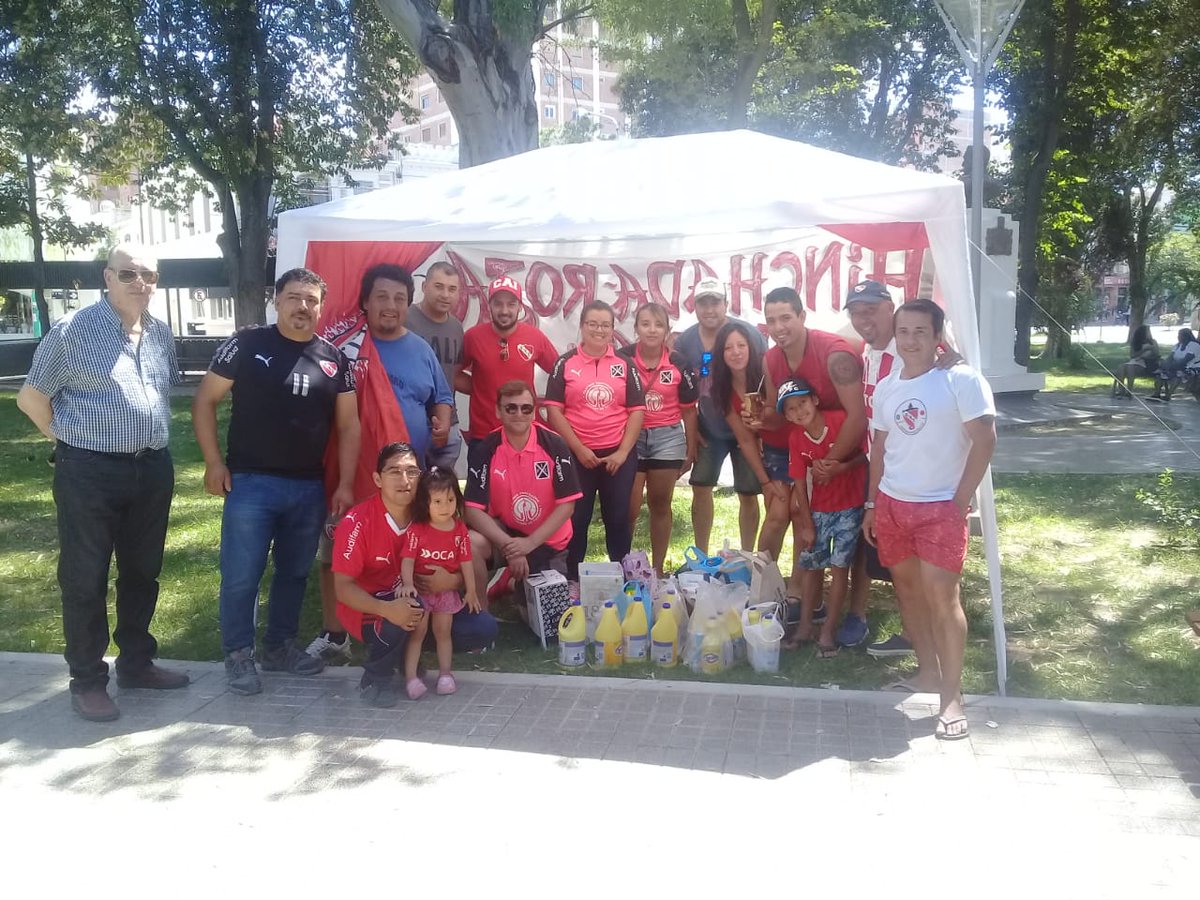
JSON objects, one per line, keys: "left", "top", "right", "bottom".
{"left": 54, "top": 442, "right": 175, "bottom": 691}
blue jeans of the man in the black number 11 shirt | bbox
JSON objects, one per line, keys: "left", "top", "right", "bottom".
{"left": 221, "top": 472, "right": 325, "bottom": 653}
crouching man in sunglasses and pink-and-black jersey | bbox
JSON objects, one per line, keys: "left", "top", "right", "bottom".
{"left": 467, "top": 382, "right": 583, "bottom": 584}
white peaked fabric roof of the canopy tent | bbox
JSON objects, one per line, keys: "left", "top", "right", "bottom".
{"left": 281, "top": 131, "right": 962, "bottom": 242}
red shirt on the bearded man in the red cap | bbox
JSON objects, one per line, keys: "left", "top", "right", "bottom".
{"left": 451, "top": 322, "right": 558, "bottom": 438}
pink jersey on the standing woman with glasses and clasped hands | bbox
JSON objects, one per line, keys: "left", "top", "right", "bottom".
{"left": 546, "top": 344, "right": 646, "bottom": 450}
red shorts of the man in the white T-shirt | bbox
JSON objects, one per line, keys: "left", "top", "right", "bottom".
{"left": 875, "top": 493, "right": 967, "bottom": 575}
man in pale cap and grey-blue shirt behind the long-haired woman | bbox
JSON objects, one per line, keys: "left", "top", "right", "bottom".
{"left": 674, "top": 278, "right": 767, "bottom": 553}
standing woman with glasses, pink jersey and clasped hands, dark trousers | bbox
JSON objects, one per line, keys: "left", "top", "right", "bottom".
{"left": 545, "top": 300, "right": 646, "bottom": 578}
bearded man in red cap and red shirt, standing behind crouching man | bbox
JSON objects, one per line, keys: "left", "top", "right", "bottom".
{"left": 454, "top": 275, "right": 558, "bottom": 456}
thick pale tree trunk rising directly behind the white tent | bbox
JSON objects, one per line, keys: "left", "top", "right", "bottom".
{"left": 377, "top": 0, "right": 545, "bottom": 168}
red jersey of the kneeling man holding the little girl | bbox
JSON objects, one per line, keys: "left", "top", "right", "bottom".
{"left": 332, "top": 493, "right": 404, "bottom": 641}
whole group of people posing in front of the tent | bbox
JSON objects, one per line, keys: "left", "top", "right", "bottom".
{"left": 18, "top": 245, "right": 995, "bottom": 738}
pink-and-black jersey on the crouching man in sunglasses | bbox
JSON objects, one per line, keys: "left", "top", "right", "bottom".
{"left": 467, "top": 424, "right": 583, "bottom": 550}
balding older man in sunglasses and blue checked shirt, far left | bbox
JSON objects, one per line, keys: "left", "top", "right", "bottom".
{"left": 17, "top": 244, "right": 188, "bottom": 721}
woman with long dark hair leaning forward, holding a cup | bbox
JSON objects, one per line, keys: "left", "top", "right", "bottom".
{"left": 713, "top": 322, "right": 792, "bottom": 550}
